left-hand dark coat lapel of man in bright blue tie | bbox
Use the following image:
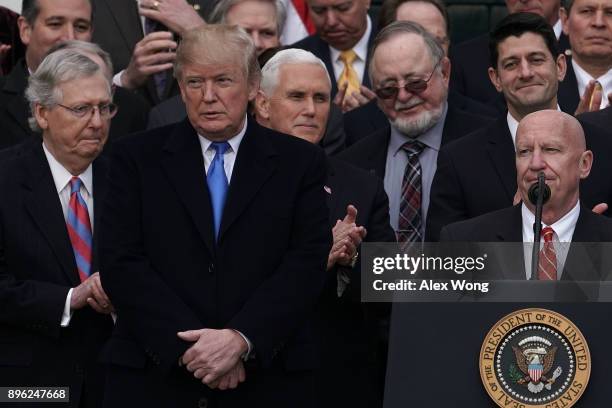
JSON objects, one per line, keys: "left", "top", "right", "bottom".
{"left": 161, "top": 119, "right": 215, "bottom": 254}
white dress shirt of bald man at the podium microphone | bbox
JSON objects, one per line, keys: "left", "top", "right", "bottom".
{"left": 521, "top": 201, "right": 580, "bottom": 279}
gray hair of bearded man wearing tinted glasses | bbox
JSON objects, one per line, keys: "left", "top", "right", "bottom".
{"left": 368, "top": 21, "right": 445, "bottom": 83}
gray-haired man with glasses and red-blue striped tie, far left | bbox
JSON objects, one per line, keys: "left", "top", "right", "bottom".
{"left": 0, "top": 50, "right": 116, "bottom": 408}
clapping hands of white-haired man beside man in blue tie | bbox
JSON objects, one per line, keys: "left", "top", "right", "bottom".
{"left": 327, "top": 204, "right": 367, "bottom": 270}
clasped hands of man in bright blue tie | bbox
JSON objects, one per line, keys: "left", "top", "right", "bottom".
{"left": 177, "top": 329, "right": 248, "bottom": 390}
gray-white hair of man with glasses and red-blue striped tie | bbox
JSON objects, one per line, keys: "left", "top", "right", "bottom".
{"left": 25, "top": 49, "right": 112, "bottom": 132}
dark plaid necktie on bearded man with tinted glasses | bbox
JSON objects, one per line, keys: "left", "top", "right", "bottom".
{"left": 397, "top": 140, "right": 425, "bottom": 243}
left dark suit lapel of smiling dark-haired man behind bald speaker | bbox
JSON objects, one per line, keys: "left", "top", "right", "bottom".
{"left": 486, "top": 117, "right": 522, "bottom": 202}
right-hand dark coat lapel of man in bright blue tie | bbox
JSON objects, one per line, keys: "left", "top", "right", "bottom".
{"left": 219, "top": 120, "right": 276, "bottom": 242}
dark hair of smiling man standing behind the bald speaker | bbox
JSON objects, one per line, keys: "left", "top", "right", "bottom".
{"left": 489, "top": 13, "right": 559, "bottom": 69}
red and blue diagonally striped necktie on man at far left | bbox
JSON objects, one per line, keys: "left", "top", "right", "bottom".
{"left": 66, "top": 177, "right": 92, "bottom": 282}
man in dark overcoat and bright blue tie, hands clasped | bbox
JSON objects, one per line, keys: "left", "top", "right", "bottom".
{"left": 100, "top": 25, "right": 331, "bottom": 407}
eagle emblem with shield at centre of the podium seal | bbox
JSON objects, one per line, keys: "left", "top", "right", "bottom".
{"left": 510, "top": 336, "right": 563, "bottom": 394}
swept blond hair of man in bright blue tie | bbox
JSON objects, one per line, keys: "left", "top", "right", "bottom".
{"left": 174, "top": 24, "right": 261, "bottom": 84}
